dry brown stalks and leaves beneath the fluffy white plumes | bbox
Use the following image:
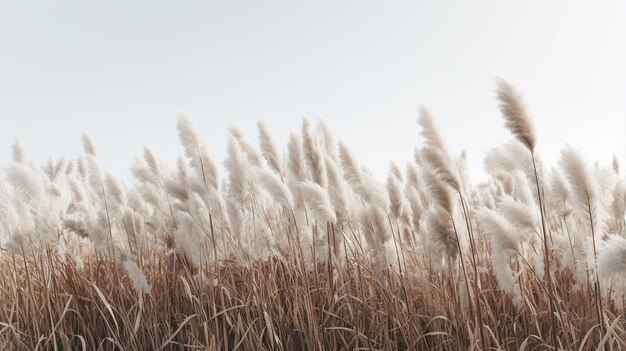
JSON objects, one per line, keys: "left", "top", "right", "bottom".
{"left": 1, "top": 243, "right": 626, "bottom": 350}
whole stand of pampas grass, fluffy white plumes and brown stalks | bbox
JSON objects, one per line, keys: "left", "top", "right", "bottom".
{"left": 0, "top": 81, "right": 626, "bottom": 350}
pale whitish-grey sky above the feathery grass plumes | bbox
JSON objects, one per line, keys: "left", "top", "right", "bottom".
{"left": 0, "top": 0, "right": 626, "bottom": 184}
